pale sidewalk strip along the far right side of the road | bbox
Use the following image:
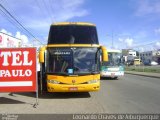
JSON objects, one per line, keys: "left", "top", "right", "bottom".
{"left": 125, "top": 71, "right": 160, "bottom": 78}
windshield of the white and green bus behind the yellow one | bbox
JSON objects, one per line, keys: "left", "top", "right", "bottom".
{"left": 103, "top": 52, "right": 122, "bottom": 66}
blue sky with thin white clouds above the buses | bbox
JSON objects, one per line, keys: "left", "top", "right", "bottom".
{"left": 0, "top": 0, "right": 160, "bottom": 51}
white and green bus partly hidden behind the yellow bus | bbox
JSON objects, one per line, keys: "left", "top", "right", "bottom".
{"left": 101, "top": 49, "right": 124, "bottom": 79}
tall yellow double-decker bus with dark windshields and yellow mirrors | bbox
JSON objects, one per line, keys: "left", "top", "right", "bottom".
{"left": 39, "top": 22, "right": 108, "bottom": 92}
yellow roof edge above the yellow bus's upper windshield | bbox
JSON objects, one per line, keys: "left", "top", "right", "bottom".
{"left": 52, "top": 22, "right": 95, "bottom": 26}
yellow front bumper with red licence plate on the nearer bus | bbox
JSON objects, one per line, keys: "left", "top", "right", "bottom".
{"left": 47, "top": 81, "right": 100, "bottom": 92}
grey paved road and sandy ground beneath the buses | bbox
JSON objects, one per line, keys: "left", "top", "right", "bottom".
{"left": 0, "top": 74, "right": 160, "bottom": 114}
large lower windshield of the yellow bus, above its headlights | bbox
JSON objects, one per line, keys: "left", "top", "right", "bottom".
{"left": 47, "top": 48, "right": 100, "bottom": 75}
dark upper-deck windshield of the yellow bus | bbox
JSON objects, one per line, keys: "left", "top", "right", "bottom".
{"left": 48, "top": 25, "right": 99, "bottom": 44}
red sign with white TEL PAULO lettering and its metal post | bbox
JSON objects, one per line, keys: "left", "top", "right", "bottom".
{"left": 0, "top": 48, "right": 38, "bottom": 105}
